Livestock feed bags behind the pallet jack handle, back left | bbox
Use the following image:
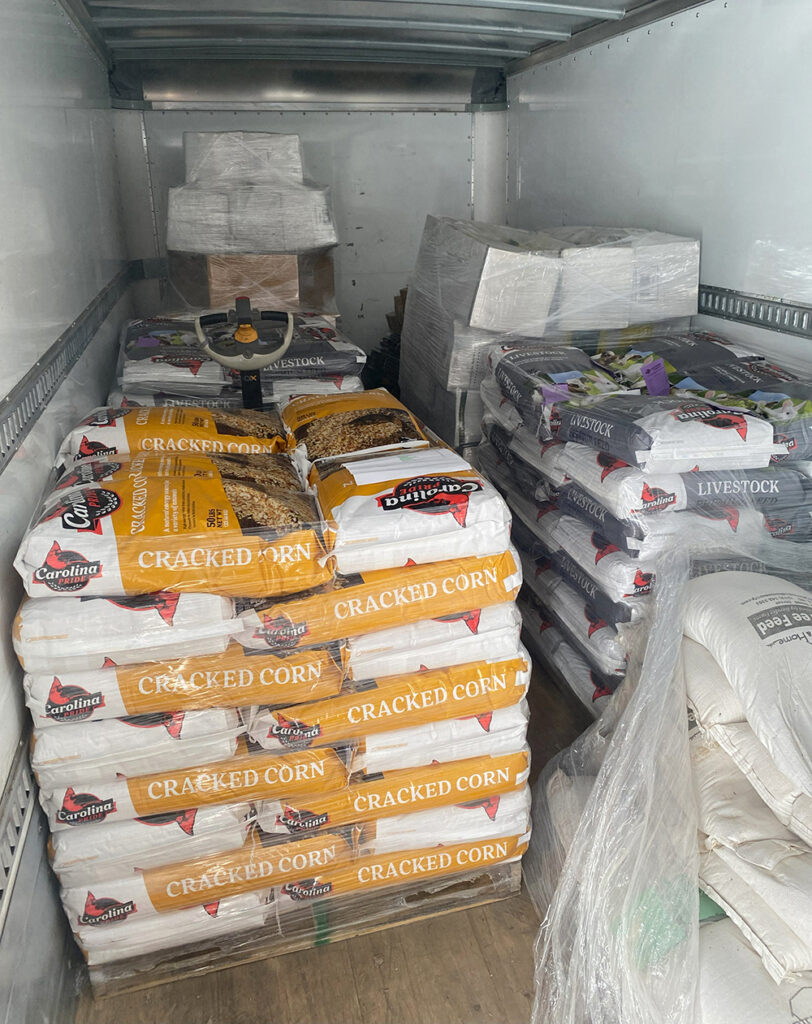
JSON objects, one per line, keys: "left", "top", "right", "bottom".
{"left": 109, "top": 313, "right": 367, "bottom": 409}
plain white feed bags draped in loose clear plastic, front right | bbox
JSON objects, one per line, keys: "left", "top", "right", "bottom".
{"left": 525, "top": 541, "right": 812, "bottom": 1024}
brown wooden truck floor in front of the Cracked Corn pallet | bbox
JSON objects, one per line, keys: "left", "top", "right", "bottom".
{"left": 76, "top": 669, "right": 591, "bottom": 1024}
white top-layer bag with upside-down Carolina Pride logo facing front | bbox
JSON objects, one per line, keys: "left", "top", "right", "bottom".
{"left": 310, "top": 447, "right": 510, "bottom": 573}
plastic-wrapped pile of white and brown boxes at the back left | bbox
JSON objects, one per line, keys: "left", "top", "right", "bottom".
{"left": 167, "top": 131, "right": 338, "bottom": 312}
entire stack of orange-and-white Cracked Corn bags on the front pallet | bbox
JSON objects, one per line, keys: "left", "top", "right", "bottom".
{"left": 13, "top": 390, "right": 529, "bottom": 980}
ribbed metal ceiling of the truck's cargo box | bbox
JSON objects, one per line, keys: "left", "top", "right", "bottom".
{"left": 60, "top": 0, "right": 706, "bottom": 71}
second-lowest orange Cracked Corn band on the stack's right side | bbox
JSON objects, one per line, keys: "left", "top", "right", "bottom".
{"left": 260, "top": 750, "right": 530, "bottom": 834}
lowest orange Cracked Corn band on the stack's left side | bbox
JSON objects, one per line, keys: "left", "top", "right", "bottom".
{"left": 142, "top": 833, "right": 352, "bottom": 913}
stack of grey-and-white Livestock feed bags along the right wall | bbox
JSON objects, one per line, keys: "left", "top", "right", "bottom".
{"left": 477, "top": 335, "right": 812, "bottom": 711}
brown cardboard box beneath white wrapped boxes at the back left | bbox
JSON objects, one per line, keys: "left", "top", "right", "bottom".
{"left": 168, "top": 250, "right": 336, "bottom": 313}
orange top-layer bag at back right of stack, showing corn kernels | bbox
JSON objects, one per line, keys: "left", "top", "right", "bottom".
{"left": 282, "top": 388, "right": 429, "bottom": 467}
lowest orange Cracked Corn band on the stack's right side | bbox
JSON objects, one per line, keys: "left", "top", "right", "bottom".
{"left": 279, "top": 836, "right": 529, "bottom": 901}
